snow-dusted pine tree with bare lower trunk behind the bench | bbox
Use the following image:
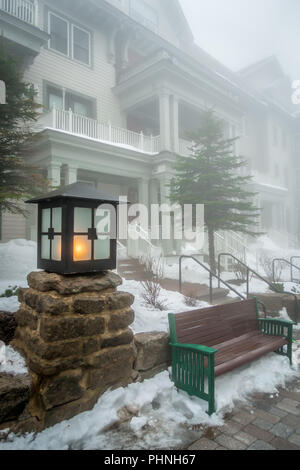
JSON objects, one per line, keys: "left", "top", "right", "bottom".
{"left": 170, "top": 110, "right": 259, "bottom": 272}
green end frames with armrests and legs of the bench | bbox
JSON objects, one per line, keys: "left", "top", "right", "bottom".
{"left": 169, "top": 299, "right": 295, "bottom": 415}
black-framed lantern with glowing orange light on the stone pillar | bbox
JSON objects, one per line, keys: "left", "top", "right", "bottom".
{"left": 27, "top": 183, "right": 119, "bottom": 274}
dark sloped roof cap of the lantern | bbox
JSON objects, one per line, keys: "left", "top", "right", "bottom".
{"left": 26, "top": 183, "right": 119, "bottom": 204}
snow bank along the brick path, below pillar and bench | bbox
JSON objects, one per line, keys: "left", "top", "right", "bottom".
{"left": 0, "top": 354, "right": 300, "bottom": 450}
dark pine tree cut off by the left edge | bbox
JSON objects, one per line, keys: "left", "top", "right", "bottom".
{"left": 0, "top": 44, "right": 47, "bottom": 214}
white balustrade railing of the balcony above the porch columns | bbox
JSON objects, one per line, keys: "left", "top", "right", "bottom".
{"left": 38, "top": 108, "right": 160, "bottom": 154}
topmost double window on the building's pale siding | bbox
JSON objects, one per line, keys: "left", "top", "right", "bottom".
{"left": 48, "top": 12, "right": 91, "bottom": 65}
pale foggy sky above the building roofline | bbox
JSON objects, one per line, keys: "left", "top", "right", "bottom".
{"left": 180, "top": 0, "right": 300, "bottom": 80}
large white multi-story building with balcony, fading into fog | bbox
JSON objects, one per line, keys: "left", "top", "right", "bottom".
{"left": 0, "top": 0, "right": 299, "bottom": 254}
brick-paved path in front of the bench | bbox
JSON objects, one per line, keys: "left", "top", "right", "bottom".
{"left": 188, "top": 379, "right": 300, "bottom": 450}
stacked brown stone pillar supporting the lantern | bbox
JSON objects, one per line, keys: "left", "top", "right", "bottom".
{"left": 12, "top": 272, "right": 135, "bottom": 428}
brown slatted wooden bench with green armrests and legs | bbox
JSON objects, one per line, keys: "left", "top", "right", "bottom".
{"left": 169, "top": 299, "right": 294, "bottom": 415}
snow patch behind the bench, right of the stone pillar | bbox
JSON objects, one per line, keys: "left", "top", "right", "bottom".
{"left": 118, "top": 280, "right": 209, "bottom": 333}
